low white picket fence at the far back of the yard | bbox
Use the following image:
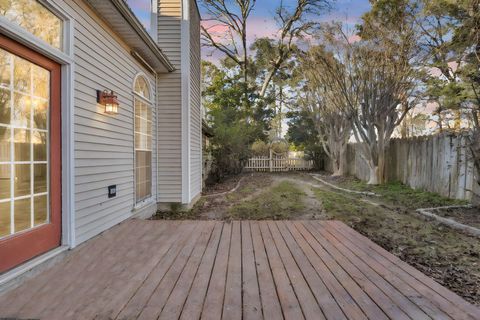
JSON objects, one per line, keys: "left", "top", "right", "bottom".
{"left": 245, "top": 156, "right": 313, "bottom": 172}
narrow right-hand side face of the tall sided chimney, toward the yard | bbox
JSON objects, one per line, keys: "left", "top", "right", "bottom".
{"left": 190, "top": 0, "right": 202, "bottom": 199}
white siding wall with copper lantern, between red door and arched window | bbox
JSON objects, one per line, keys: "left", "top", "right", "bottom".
{"left": 56, "top": 0, "right": 157, "bottom": 244}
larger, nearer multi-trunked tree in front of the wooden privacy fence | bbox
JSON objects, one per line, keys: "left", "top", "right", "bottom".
{"left": 351, "top": 0, "right": 419, "bottom": 184}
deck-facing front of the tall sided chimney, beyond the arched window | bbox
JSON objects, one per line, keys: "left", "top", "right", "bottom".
{"left": 157, "top": 0, "right": 182, "bottom": 202}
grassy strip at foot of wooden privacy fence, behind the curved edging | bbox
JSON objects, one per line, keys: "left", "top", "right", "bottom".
{"left": 339, "top": 179, "right": 468, "bottom": 209}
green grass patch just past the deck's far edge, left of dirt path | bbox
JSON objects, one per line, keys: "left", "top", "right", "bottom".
{"left": 228, "top": 181, "right": 305, "bottom": 220}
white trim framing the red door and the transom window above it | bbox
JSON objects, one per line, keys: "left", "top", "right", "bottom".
{"left": 0, "top": 0, "right": 76, "bottom": 248}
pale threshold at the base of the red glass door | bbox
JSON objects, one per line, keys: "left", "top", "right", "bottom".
{"left": 0, "top": 246, "right": 68, "bottom": 294}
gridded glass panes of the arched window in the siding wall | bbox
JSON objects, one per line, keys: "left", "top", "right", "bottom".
{"left": 134, "top": 76, "right": 152, "bottom": 202}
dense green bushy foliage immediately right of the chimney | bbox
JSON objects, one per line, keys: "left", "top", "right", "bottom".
{"left": 202, "top": 62, "right": 270, "bottom": 181}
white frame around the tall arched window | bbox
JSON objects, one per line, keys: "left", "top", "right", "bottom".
{"left": 132, "top": 72, "right": 156, "bottom": 211}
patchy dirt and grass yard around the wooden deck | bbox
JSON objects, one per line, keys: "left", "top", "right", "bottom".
{"left": 158, "top": 173, "right": 480, "bottom": 305}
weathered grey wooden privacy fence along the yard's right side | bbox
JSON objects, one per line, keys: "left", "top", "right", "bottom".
{"left": 326, "top": 133, "right": 479, "bottom": 200}
